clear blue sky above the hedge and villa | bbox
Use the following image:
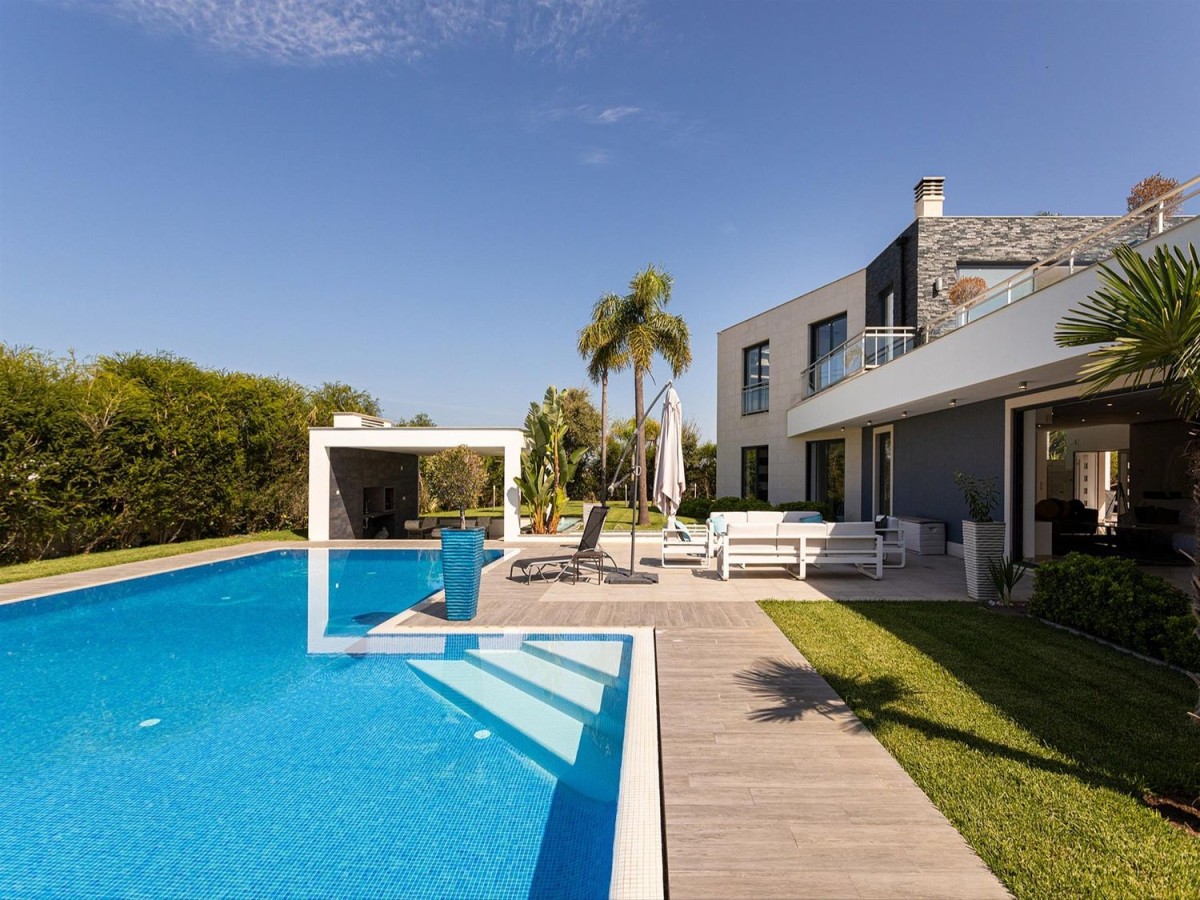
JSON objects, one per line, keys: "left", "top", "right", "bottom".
{"left": 0, "top": 0, "right": 1200, "bottom": 438}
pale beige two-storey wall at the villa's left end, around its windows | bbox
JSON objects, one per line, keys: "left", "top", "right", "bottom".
{"left": 716, "top": 270, "right": 866, "bottom": 503}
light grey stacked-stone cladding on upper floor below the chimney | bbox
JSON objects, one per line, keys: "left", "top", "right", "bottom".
{"left": 916, "top": 216, "right": 1116, "bottom": 326}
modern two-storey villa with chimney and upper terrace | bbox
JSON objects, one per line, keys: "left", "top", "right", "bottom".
{"left": 716, "top": 178, "right": 1200, "bottom": 557}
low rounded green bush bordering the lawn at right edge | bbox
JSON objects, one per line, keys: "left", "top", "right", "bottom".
{"left": 1030, "top": 553, "right": 1200, "bottom": 671}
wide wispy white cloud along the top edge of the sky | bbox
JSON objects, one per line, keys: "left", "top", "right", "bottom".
{"left": 68, "top": 0, "right": 638, "bottom": 65}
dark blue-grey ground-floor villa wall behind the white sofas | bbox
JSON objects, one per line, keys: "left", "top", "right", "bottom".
{"left": 888, "top": 400, "right": 1004, "bottom": 544}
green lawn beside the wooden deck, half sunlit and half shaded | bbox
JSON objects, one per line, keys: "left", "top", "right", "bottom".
{"left": 762, "top": 600, "right": 1200, "bottom": 898}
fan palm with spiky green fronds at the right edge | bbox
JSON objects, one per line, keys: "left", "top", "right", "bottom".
{"left": 1055, "top": 244, "right": 1200, "bottom": 720}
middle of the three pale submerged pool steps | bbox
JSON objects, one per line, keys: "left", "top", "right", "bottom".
{"left": 466, "top": 648, "right": 622, "bottom": 736}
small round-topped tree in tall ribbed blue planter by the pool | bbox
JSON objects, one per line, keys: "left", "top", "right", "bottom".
{"left": 425, "top": 446, "right": 487, "bottom": 622}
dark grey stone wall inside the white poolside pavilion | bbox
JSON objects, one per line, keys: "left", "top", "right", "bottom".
{"left": 329, "top": 446, "right": 418, "bottom": 540}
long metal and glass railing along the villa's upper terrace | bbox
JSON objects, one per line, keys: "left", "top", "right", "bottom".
{"left": 804, "top": 175, "right": 1200, "bottom": 397}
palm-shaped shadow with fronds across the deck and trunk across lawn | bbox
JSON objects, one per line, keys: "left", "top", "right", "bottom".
{"left": 734, "top": 659, "right": 1130, "bottom": 791}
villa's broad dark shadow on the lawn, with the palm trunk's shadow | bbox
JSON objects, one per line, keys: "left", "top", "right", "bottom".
{"left": 844, "top": 604, "right": 1200, "bottom": 798}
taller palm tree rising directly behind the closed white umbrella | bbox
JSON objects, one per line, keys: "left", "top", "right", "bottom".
{"left": 583, "top": 265, "right": 691, "bottom": 526}
